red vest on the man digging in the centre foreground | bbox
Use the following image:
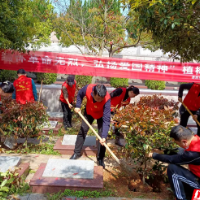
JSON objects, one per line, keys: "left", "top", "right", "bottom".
{"left": 86, "top": 84, "right": 110, "bottom": 119}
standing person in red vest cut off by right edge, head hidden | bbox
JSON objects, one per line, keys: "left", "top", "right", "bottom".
{"left": 178, "top": 83, "right": 200, "bottom": 136}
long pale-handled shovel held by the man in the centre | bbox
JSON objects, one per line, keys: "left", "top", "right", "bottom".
{"left": 78, "top": 112, "right": 133, "bottom": 175}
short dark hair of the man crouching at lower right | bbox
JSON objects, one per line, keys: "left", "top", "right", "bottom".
{"left": 170, "top": 125, "right": 194, "bottom": 142}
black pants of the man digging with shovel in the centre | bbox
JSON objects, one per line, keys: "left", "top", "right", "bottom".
{"left": 74, "top": 111, "right": 106, "bottom": 160}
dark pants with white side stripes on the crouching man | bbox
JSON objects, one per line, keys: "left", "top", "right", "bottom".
{"left": 167, "top": 164, "right": 200, "bottom": 200}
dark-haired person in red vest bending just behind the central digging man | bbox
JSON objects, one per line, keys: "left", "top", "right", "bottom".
{"left": 110, "top": 86, "right": 140, "bottom": 146}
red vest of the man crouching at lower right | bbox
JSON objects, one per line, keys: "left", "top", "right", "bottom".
{"left": 186, "top": 135, "right": 200, "bottom": 177}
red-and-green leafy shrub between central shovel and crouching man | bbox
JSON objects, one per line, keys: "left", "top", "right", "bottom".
{"left": 114, "top": 95, "right": 177, "bottom": 182}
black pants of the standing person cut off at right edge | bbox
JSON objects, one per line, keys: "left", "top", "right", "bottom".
{"left": 180, "top": 105, "right": 200, "bottom": 136}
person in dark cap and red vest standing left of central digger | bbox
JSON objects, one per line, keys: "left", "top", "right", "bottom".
{"left": 60, "top": 75, "right": 76, "bottom": 130}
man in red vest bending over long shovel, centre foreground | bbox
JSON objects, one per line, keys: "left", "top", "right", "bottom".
{"left": 70, "top": 84, "right": 110, "bottom": 168}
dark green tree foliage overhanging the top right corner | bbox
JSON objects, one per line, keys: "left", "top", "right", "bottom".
{"left": 123, "top": 0, "right": 200, "bottom": 61}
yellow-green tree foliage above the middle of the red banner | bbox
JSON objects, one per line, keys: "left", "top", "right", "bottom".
{"left": 53, "top": 0, "right": 152, "bottom": 56}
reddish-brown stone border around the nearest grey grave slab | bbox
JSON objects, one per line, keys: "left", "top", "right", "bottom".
{"left": 29, "top": 163, "right": 103, "bottom": 194}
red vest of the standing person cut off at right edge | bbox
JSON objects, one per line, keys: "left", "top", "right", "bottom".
{"left": 183, "top": 83, "right": 200, "bottom": 111}
